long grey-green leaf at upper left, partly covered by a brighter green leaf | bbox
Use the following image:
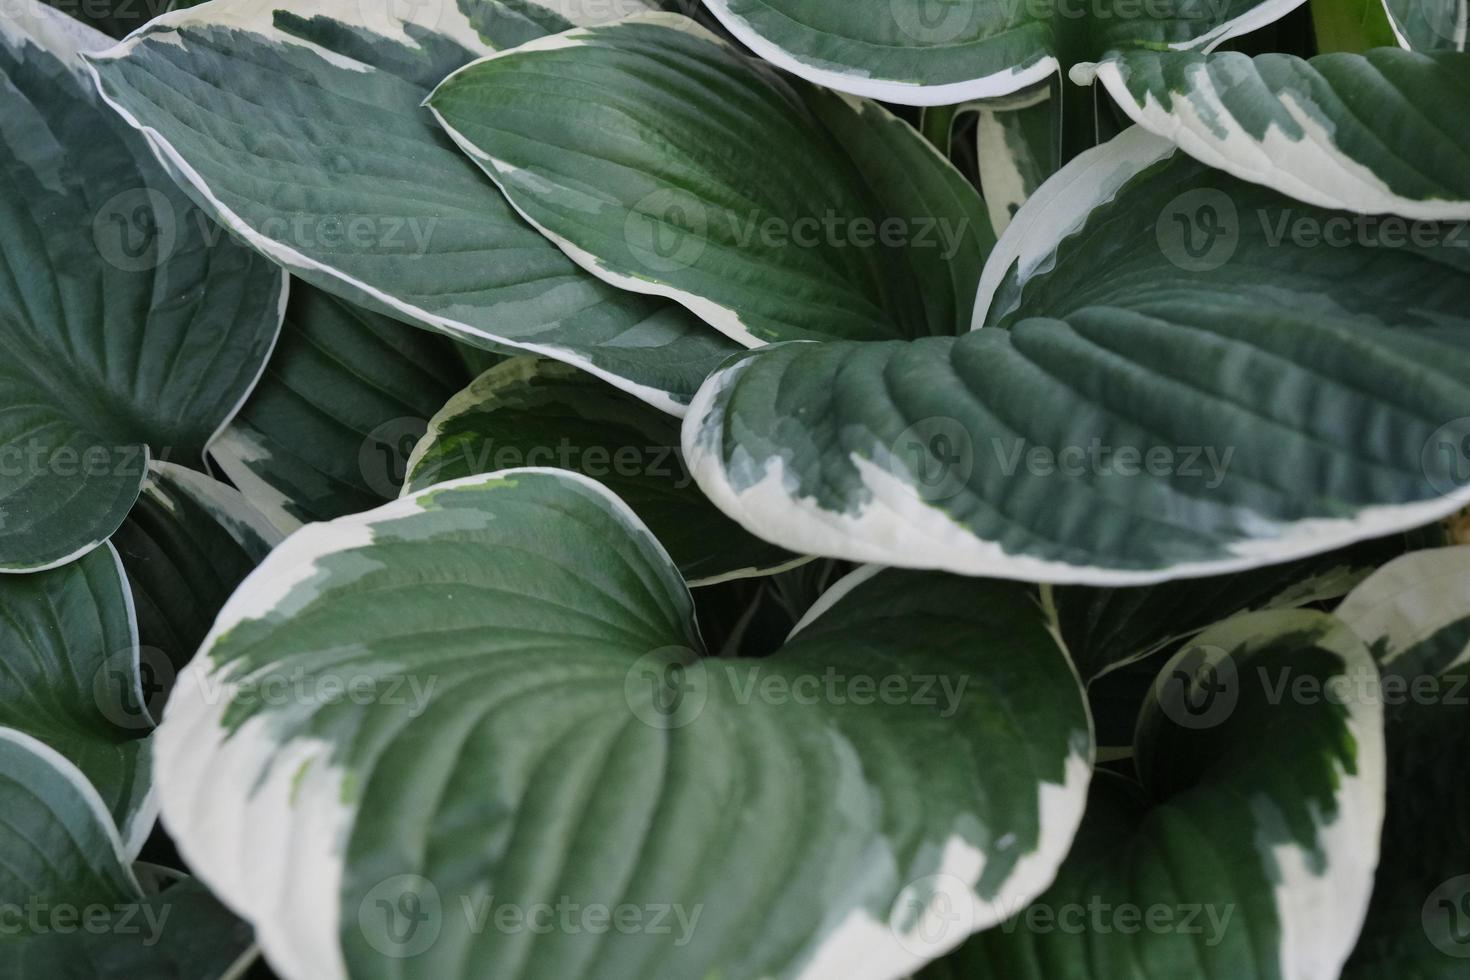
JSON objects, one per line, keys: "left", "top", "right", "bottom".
{"left": 83, "top": 0, "right": 732, "bottom": 411}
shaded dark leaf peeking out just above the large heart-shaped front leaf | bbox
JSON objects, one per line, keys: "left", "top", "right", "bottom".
{"left": 403, "top": 357, "right": 803, "bottom": 585}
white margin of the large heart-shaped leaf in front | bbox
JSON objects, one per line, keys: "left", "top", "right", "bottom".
{"left": 163, "top": 467, "right": 1095, "bottom": 980}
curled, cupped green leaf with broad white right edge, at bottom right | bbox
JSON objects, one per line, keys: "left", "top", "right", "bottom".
{"left": 923, "top": 610, "right": 1385, "bottom": 980}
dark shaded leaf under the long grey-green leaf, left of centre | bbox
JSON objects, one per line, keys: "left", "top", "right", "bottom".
{"left": 210, "top": 282, "right": 494, "bottom": 533}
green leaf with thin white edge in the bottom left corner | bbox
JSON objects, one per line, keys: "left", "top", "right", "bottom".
{"left": 0, "top": 727, "right": 251, "bottom": 980}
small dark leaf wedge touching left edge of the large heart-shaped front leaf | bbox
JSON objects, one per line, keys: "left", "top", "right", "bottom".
{"left": 112, "top": 463, "right": 282, "bottom": 675}
